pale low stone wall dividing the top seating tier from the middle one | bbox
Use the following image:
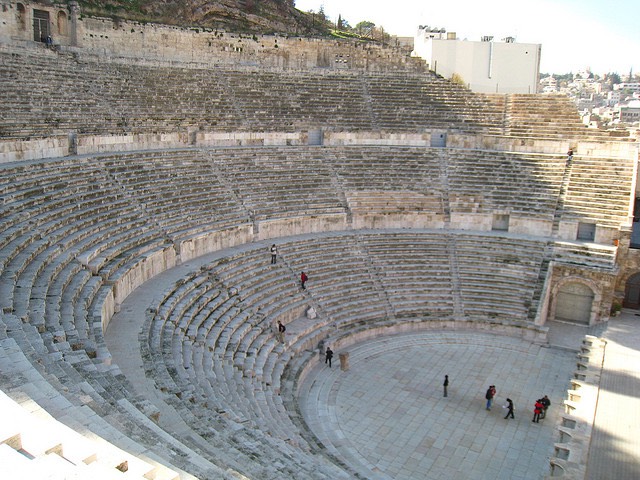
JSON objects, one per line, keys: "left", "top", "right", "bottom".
{"left": 0, "top": 129, "right": 638, "bottom": 166}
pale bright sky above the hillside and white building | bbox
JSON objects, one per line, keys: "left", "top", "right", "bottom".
{"left": 295, "top": 0, "right": 640, "bottom": 75}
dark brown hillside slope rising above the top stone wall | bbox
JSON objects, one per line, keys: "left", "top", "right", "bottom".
{"left": 79, "top": 0, "right": 325, "bottom": 35}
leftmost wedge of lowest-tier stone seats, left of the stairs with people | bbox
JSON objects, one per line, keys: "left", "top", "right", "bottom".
{"left": 142, "top": 272, "right": 342, "bottom": 478}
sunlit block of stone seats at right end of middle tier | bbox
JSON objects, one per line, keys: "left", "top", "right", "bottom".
{"left": 563, "top": 156, "right": 635, "bottom": 228}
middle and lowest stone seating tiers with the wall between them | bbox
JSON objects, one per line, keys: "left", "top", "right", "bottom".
{"left": 0, "top": 142, "right": 627, "bottom": 478}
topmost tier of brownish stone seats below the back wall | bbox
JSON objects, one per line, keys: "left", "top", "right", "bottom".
{"left": 0, "top": 50, "right": 616, "bottom": 139}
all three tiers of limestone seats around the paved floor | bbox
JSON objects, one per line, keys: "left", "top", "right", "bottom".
{"left": 0, "top": 38, "right": 633, "bottom": 479}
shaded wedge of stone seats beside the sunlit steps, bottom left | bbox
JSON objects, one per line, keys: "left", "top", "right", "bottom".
{"left": 0, "top": 313, "right": 237, "bottom": 480}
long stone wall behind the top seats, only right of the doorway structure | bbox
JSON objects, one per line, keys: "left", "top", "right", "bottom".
{"left": 78, "top": 18, "right": 425, "bottom": 71}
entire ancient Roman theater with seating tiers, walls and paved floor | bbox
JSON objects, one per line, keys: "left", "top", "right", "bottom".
{"left": 0, "top": 0, "right": 640, "bottom": 480}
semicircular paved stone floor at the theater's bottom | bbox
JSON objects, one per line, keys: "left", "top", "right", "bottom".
{"left": 300, "top": 332, "right": 576, "bottom": 480}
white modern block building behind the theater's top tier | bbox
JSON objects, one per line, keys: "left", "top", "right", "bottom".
{"left": 413, "top": 27, "right": 541, "bottom": 93}
